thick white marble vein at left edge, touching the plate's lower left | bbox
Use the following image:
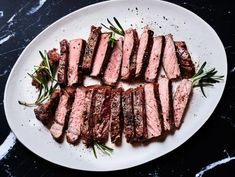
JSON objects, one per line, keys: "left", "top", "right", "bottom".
{"left": 0, "top": 132, "right": 16, "bottom": 160}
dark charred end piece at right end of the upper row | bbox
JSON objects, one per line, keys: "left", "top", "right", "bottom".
{"left": 175, "top": 41, "right": 195, "bottom": 79}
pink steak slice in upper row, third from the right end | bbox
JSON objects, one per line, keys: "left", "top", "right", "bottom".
{"left": 145, "top": 36, "right": 164, "bottom": 82}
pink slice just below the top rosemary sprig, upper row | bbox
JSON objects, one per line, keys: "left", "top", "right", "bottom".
{"left": 102, "top": 38, "right": 123, "bottom": 86}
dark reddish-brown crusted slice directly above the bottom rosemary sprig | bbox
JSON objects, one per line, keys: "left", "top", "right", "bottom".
{"left": 93, "top": 88, "right": 111, "bottom": 143}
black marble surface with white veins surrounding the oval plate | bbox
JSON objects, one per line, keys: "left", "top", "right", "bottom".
{"left": 0, "top": 0, "right": 235, "bottom": 177}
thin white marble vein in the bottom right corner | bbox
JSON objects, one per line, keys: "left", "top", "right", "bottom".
{"left": 195, "top": 151, "right": 235, "bottom": 177}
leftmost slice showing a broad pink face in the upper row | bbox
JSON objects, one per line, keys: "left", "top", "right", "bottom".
{"left": 68, "top": 39, "right": 85, "bottom": 86}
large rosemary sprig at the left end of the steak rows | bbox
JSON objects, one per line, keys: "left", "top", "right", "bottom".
{"left": 18, "top": 51, "right": 57, "bottom": 106}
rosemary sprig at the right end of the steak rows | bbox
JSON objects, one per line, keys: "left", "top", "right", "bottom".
{"left": 191, "top": 62, "right": 224, "bottom": 97}
